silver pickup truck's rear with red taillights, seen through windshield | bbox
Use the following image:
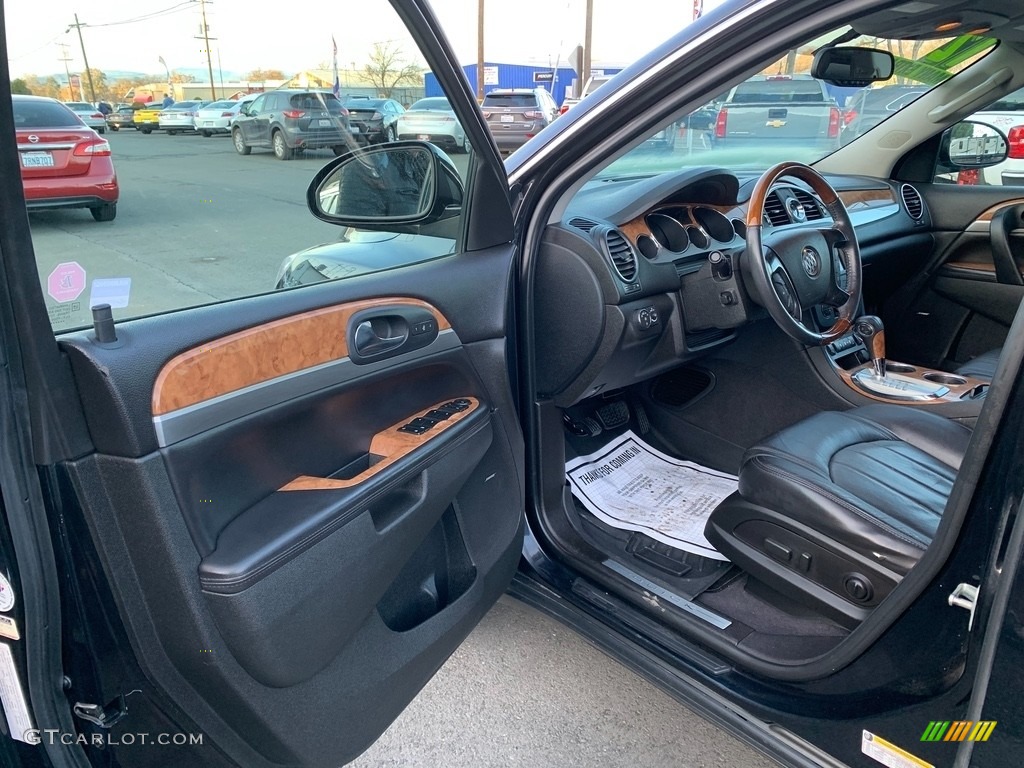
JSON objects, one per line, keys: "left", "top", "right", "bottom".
{"left": 714, "top": 75, "right": 842, "bottom": 153}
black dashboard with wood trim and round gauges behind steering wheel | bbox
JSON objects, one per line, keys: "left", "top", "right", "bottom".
{"left": 534, "top": 168, "right": 931, "bottom": 407}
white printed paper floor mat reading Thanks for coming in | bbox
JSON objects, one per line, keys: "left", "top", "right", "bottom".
{"left": 565, "top": 431, "right": 736, "bottom": 560}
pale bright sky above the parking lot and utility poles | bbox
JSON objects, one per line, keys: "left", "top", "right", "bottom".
{"left": 3, "top": 0, "right": 733, "bottom": 77}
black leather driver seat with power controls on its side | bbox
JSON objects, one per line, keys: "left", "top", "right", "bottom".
{"left": 705, "top": 404, "right": 971, "bottom": 628}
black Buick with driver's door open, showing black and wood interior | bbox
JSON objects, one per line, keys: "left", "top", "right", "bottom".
{"left": 8, "top": 0, "right": 1024, "bottom": 768}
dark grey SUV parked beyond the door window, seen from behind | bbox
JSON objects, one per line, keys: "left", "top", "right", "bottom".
{"left": 231, "top": 89, "right": 356, "bottom": 160}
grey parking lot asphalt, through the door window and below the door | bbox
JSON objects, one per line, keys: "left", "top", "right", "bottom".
{"left": 30, "top": 130, "right": 775, "bottom": 768}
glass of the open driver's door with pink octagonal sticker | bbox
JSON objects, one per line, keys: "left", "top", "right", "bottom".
{"left": 5, "top": 0, "right": 474, "bottom": 332}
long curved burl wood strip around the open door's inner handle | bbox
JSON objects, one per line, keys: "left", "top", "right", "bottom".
{"left": 153, "top": 297, "right": 452, "bottom": 416}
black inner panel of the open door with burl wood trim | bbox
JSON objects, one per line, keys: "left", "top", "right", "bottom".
{"left": 51, "top": 248, "right": 523, "bottom": 766}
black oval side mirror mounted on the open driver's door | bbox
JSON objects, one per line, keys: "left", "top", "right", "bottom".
{"left": 306, "top": 141, "right": 463, "bottom": 231}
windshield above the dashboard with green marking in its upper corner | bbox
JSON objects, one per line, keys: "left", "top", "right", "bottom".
{"left": 599, "top": 28, "right": 992, "bottom": 178}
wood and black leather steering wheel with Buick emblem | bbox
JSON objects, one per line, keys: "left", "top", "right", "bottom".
{"left": 746, "top": 162, "right": 862, "bottom": 345}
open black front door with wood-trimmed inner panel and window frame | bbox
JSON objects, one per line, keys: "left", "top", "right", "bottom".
{"left": 0, "top": 0, "right": 524, "bottom": 768}
